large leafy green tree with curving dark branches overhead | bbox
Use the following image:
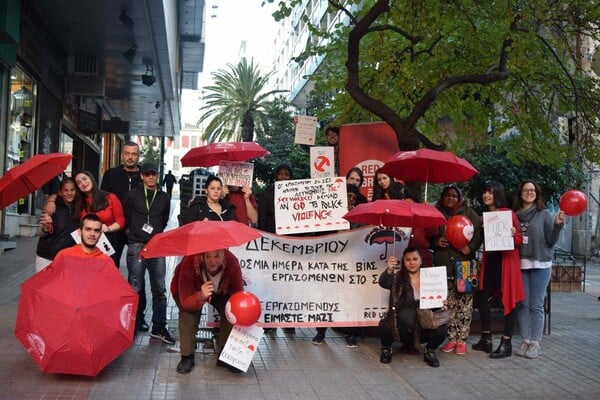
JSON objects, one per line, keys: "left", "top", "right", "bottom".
{"left": 265, "top": 0, "right": 600, "bottom": 167}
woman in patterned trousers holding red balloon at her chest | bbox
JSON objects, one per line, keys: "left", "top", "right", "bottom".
{"left": 432, "top": 185, "right": 483, "bottom": 355}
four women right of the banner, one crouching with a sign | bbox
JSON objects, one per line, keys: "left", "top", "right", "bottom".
{"left": 376, "top": 175, "right": 565, "bottom": 367}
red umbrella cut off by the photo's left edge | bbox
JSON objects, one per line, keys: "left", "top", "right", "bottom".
{"left": 0, "top": 153, "right": 73, "bottom": 209}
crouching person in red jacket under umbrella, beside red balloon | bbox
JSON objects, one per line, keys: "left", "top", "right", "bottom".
{"left": 171, "top": 249, "right": 244, "bottom": 374}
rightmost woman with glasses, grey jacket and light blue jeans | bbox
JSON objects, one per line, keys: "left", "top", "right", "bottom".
{"left": 513, "top": 180, "right": 565, "bottom": 358}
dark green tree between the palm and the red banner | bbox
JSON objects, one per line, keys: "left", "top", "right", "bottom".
{"left": 254, "top": 97, "right": 310, "bottom": 188}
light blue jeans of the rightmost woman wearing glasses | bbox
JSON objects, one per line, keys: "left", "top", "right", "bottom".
{"left": 517, "top": 268, "right": 552, "bottom": 342}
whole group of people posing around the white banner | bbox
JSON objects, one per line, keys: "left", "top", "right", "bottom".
{"left": 36, "top": 131, "right": 565, "bottom": 374}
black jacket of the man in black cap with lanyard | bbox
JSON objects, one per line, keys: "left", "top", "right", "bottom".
{"left": 123, "top": 185, "right": 171, "bottom": 243}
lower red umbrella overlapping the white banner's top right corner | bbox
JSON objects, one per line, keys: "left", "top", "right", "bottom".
{"left": 344, "top": 200, "right": 446, "bottom": 228}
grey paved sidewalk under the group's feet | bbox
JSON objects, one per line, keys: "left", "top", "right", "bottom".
{"left": 0, "top": 222, "right": 600, "bottom": 400}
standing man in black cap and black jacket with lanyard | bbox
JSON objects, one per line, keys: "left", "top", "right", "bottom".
{"left": 123, "top": 164, "right": 175, "bottom": 344}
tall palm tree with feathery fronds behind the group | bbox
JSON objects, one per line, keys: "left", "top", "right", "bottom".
{"left": 197, "top": 58, "right": 285, "bottom": 143}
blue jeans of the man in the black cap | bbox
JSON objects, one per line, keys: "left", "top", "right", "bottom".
{"left": 127, "top": 243, "right": 167, "bottom": 331}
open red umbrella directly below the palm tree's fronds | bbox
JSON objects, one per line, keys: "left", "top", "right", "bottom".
{"left": 181, "top": 142, "right": 268, "bottom": 167}
